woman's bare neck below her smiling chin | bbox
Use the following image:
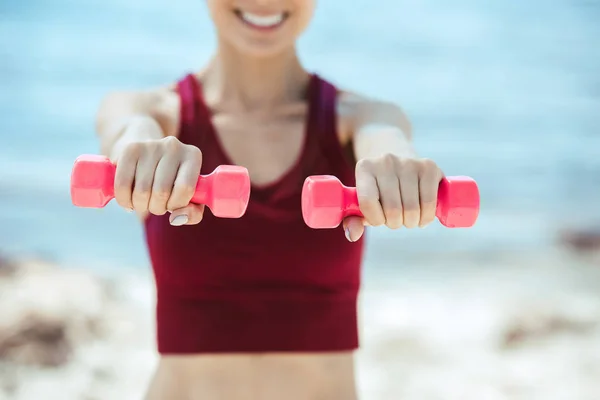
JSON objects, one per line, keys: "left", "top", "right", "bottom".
{"left": 202, "top": 41, "right": 309, "bottom": 110}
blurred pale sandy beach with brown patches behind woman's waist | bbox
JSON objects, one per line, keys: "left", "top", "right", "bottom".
{"left": 0, "top": 245, "right": 600, "bottom": 400}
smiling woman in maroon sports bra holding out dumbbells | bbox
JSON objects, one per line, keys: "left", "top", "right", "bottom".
{"left": 97, "top": 0, "right": 442, "bottom": 400}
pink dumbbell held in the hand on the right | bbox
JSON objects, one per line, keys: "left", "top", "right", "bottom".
{"left": 302, "top": 175, "right": 479, "bottom": 229}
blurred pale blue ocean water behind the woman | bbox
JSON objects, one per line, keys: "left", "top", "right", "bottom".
{"left": 0, "top": 0, "right": 600, "bottom": 268}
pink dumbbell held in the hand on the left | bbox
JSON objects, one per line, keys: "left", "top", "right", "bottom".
{"left": 71, "top": 154, "right": 250, "bottom": 218}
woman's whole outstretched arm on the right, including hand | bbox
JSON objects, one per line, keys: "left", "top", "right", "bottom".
{"left": 338, "top": 92, "right": 443, "bottom": 241}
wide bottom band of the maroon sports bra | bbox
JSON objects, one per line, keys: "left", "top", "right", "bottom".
{"left": 156, "top": 294, "right": 359, "bottom": 354}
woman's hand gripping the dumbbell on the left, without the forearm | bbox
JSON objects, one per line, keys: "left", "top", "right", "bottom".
{"left": 115, "top": 136, "right": 204, "bottom": 226}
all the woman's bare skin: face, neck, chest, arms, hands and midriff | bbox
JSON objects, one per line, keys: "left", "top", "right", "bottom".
{"left": 96, "top": 0, "right": 443, "bottom": 400}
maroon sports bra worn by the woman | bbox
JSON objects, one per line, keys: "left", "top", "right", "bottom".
{"left": 145, "top": 75, "right": 363, "bottom": 354}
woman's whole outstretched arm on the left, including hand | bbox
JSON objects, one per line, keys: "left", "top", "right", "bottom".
{"left": 96, "top": 88, "right": 204, "bottom": 225}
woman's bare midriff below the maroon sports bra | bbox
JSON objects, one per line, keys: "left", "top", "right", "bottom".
{"left": 146, "top": 352, "right": 357, "bottom": 400}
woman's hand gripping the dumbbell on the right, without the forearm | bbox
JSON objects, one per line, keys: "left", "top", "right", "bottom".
{"left": 343, "top": 154, "right": 444, "bottom": 242}
